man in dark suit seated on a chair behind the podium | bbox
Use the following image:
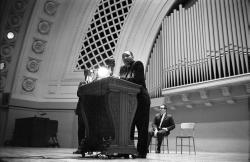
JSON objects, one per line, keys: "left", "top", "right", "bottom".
{"left": 148, "top": 105, "right": 175, "bottom": 153}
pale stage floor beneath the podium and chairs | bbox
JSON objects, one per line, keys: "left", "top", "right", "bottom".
{"left": 0, "top": 147, "right": 249, "bottom": 162}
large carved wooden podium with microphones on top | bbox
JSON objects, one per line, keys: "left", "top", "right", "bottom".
{"left": 78, "top": 77, "right": 141, "bottom": 156}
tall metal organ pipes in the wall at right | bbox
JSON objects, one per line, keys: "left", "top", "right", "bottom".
{"left": 146, "top": 0, "right": 250, "bottom": 98}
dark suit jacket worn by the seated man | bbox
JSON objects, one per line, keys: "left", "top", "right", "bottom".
{"left": 152, "top": 113, "right": 175, "bottom": 135}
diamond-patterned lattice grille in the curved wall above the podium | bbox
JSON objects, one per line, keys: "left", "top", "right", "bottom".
{"left": 75, "top": 0, "right": 134, "bottom": 71}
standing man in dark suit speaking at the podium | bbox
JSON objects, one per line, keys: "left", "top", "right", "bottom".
{"left": 119, "top": 51, "right": 150, "bottom": 158}
